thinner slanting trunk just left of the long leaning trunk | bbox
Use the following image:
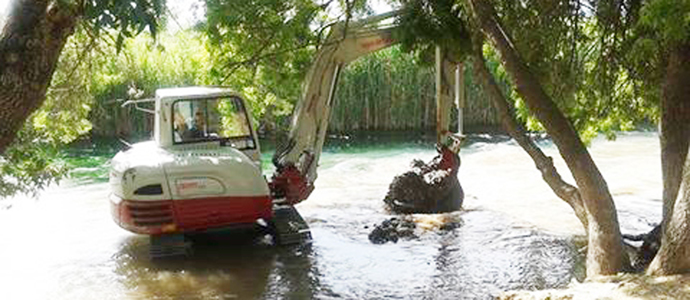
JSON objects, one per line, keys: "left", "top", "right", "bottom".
{"left": 474, "top": 51, "right": 588, "bottom": 231}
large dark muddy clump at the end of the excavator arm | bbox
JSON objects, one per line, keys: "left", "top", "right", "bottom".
{"left": 383, "top": 155, "right": 465, "bottom": 214}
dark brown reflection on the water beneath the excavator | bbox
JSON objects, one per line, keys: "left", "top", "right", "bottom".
{"left": 113, "top": 230, "right": 318, "bottom": 299}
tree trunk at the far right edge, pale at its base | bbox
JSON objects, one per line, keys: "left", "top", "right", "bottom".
{"left": 648, "top": 43, "right": 690, "bottom": 275}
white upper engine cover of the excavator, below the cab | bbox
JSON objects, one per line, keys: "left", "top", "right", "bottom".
{"left": 110, "top": 142, "right": 269, "bottom": 200}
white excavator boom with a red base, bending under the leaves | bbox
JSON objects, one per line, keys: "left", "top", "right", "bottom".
{"left": 269, "top": 11, "right": 457, "bottom": 204}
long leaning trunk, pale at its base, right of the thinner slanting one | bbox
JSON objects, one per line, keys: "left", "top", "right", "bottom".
{"left": 470, "top": 0, "right": 624, "bottom": 276}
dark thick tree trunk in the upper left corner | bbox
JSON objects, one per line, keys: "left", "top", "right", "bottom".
{"left": 0, "top": 0, "right": 76, "bottom": 153}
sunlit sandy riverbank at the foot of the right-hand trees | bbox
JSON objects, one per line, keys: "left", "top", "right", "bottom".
{"left": 498, "top": 274, "right": 690, "bottom": 300}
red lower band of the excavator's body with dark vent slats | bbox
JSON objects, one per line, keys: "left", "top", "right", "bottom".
{"left": 111, "top": 195, "right": 273, "bottom": 234}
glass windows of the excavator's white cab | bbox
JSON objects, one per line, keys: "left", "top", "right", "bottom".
{"left": 172, "top": 97, "right": 255, "bottom": 149}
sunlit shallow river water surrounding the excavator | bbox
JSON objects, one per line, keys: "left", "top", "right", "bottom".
{"left": 0, "top": 132, "right": 661, "bottom": 299}
